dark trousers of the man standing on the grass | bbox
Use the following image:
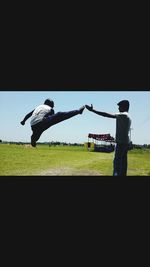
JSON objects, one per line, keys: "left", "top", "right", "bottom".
{"left": 113, "top": 144, "right": 128, "bottom": 176}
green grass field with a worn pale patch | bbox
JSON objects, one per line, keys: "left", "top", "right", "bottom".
{"left": 0, "top": 144, "right": 150, "bottom": 176}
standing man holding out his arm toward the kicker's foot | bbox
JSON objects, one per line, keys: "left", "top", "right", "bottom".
{"left": 85, "top": 100, "right": 131, "bottom": 176}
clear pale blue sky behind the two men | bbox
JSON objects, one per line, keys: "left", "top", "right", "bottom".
{"left": 0, "top": 90, "right": 150, "bottom": 144}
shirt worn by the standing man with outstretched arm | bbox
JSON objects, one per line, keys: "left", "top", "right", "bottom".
{"left": 115, "top": 112, "right": 131, "bottom": 144}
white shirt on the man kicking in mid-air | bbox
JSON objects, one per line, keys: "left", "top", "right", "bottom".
{"left": 30, "top": 104, "right": 51, "bottom": 126}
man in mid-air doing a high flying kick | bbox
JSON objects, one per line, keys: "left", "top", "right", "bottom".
{"left": 20, "top": 99, "right": 85, "bottom": 147}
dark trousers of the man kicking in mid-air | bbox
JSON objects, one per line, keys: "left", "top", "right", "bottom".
{"left": 31, "top": 110, "right": 79, "bottom": 141}
